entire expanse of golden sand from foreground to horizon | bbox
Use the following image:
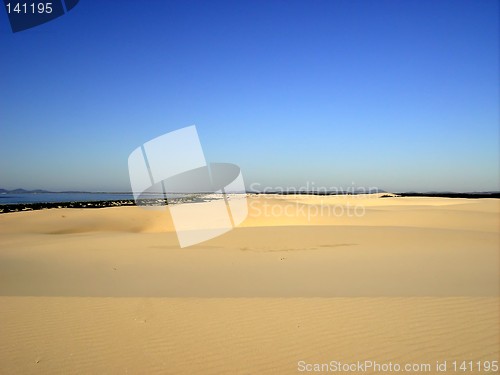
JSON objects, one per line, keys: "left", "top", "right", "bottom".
{"left": 0, "top": 194, "right": 500, "bottom": 374}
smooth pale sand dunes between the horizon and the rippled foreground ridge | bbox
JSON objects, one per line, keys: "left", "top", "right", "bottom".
{"left": 0, "top": 196, "right": 499, "bottom": 297}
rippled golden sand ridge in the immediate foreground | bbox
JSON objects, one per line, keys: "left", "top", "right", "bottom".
{"left": 0, "top": 297, "right": 500, "bottom": 374}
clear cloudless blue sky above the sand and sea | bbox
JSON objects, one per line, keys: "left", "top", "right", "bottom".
{"left": 0, "top": 0, "right": 500, "bottom": 191}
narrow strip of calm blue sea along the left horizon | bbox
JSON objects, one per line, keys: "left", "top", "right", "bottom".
{"left": 0, "top": 193, "right": 134, "bottom": 204}
